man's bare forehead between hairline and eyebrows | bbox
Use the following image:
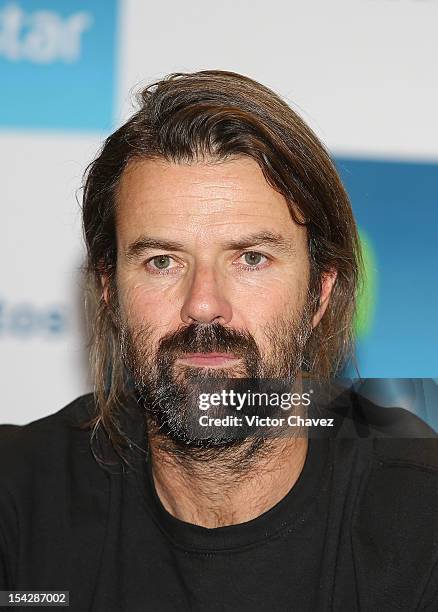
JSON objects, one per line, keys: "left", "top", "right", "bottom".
{"left": 117, "top": 157, "right": 303, "bottom": 242}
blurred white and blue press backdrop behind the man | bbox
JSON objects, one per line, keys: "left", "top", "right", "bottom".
{"left": 0, "top": 0, "right": 438, "bottom": 423}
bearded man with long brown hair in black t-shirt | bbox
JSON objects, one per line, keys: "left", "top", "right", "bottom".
{"left": 0, "top": 71, "right": 438, "bottom": 612}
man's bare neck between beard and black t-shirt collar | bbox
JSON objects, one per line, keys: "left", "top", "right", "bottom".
{"left": 150, "top": 436, "right": 308, "bottom": 528}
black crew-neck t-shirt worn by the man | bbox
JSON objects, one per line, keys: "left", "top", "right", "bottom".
{"left": 0, "top": 396, "right": 438, "bottom": 612}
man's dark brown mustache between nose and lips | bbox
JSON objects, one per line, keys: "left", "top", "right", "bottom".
{"left": 157, "top": 323, "right": 260, "bottom": 359}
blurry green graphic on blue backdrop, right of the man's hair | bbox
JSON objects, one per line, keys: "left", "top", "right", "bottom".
{"left": 354, "top": 230, "right": 377, "bottom": 340}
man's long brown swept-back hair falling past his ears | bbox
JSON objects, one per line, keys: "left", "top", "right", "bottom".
{"left": 83, "top": 70, "right": 361, "bottom": 464}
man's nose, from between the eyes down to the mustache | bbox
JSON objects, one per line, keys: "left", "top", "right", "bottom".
{"left": 181, "top": 266, "right": 232, "bottom": 325}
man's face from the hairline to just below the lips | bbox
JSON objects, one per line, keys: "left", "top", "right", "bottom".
{"left": 108, "top": 158, "right": 332, "bottom": 444}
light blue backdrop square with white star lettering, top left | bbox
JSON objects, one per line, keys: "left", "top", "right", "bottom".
{"left": 0, "top": 0, "right": 118, "bottom": 131}
